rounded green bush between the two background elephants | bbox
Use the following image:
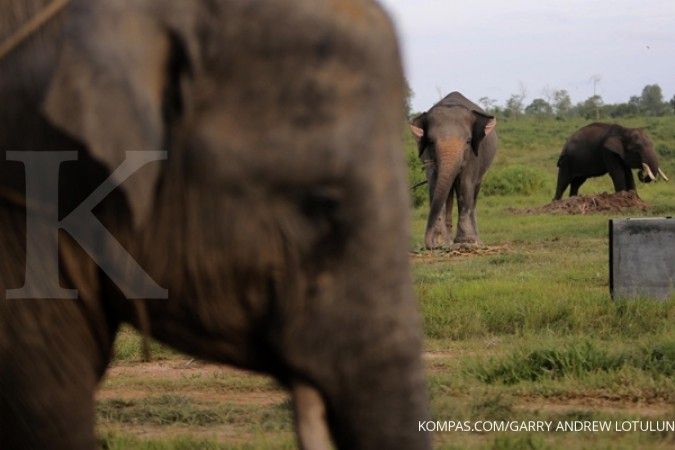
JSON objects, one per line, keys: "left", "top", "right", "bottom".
{"left": 481, "top": 165, "right": 545, "bottom": 196}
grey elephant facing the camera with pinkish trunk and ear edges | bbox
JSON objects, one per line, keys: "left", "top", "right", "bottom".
{"left": 410, "top": 92, "right": 497, "bottom": 249}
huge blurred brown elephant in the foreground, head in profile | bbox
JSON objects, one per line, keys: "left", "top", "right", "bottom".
{"left": 0, "top": 0, "right": 429, "bottom": 450}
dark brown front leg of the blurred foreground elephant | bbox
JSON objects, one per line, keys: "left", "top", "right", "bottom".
{"left": 0, "top": 209, "right": 118, "bottom": 450}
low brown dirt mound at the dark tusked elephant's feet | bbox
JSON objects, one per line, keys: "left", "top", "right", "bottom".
{"left": 509, "top": 191, "right": 649, "bottom": 214}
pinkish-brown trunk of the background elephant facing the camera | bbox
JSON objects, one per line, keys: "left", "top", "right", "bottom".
{"left": 424, "top": 138, "right": 464, "bottom": 249}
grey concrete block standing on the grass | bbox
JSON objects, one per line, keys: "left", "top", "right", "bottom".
{"left": 609, "top": 217, "right": 675, "bottom": 299}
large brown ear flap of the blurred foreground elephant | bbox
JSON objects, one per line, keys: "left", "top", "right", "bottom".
{"left": 44, "top": 1, "right": 190, "bottom": 226}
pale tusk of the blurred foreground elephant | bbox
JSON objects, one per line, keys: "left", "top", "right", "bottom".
{"left": 293, "top": 383, "right": 333, "bottom": 450}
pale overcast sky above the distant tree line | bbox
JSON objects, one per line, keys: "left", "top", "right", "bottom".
{"left": 380, "top": 0, "right": 675, "bottom": 111}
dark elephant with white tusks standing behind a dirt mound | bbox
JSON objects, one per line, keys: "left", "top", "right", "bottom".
{"left": 554, "top": 123, "right": 668, "bottom": 200}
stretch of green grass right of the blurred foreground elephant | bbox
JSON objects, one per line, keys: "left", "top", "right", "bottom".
{"left": 407, "top": 117, "right": 675, "bottom": 449}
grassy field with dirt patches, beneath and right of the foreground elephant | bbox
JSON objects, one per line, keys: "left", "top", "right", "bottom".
{"left": 97, "top": 117, "right": 675, "bottom": 450}
